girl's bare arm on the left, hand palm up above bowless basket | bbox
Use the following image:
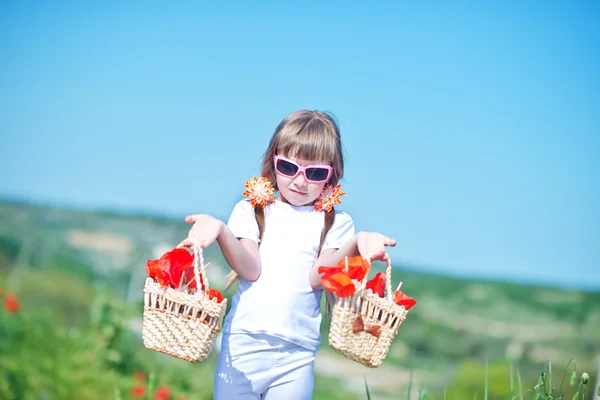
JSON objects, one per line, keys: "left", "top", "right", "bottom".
{"left": 184, "top": 214, "right": 261, "bottom": 281}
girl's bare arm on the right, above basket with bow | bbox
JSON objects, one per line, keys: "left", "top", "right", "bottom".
{"left": 310, "top": 232, "right": 396, "bottom": 289}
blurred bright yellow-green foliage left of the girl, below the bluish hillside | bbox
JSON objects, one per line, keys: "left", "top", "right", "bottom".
{"left": 0, "top": 278, "right": 220, "bottom": 399}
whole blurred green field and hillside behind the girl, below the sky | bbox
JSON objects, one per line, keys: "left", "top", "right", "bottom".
{"left": 0, "top": 201, "right": 600, "bottom": 400}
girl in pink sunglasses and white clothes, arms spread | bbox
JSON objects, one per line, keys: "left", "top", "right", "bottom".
{"left": 186, "top": 110, "right": 396, "bottom": 400}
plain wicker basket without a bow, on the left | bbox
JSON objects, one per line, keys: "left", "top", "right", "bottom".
{"left": 142, "top": 239, "right": 227, "bottom": 363}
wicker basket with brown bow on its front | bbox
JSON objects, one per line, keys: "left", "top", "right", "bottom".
{"left": 329, "top": 257, "right": 408, "bottom": 368}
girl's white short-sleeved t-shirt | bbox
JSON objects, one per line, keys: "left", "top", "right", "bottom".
{"left": 223, "top": 200, "right": 354, "bottom": 351}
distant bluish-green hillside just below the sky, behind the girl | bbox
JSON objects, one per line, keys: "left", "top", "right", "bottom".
{"left": 0, "top": 197, "right": 600, "bottom": 396}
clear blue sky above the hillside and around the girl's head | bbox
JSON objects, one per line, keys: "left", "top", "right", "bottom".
{"left": 0, "top": 1, "right": 600, "bottom": 288}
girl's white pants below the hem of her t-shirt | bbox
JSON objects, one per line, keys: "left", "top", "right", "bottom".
{"left": 214, "top": 334, "right": 315, "bottom": 400}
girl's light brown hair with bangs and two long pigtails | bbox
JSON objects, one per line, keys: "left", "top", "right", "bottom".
{"left": 225, "top": 110, "right": 344, "bottom": 314}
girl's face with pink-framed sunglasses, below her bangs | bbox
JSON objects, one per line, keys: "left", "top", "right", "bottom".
{"left": 274, "top": 157, "right": 331, "bottom": 206}
